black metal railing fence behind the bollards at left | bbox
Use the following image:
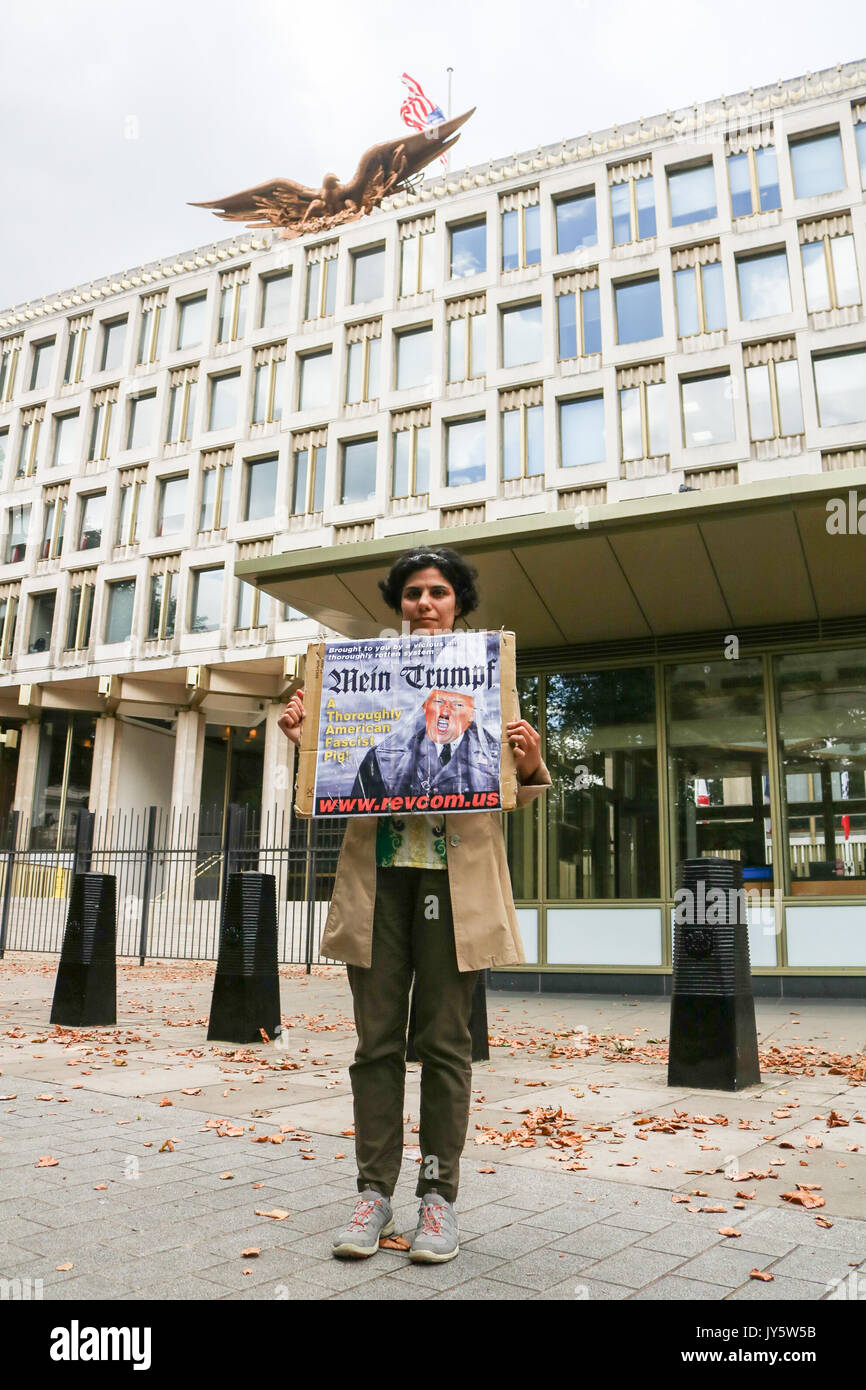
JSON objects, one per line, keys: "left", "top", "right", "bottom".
{"left": 0, "top": 805, "right": 345, "bottom": 967}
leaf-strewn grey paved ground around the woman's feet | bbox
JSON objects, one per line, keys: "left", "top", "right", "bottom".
{"left": 0, "top": 955, "right": 866, "bottom": 1301}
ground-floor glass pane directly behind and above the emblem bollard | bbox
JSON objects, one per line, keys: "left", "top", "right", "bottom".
{"left": 666, "top": 656, "right": 771, "bottom": 881}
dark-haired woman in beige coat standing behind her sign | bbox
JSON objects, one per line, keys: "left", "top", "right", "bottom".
{"left": 279, "top": 548, "right": 550, "bottom": 1262}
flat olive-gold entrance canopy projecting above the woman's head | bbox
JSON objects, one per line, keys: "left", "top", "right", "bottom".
{"left": 235, "top": 468, "right": 866, "bottom": 649}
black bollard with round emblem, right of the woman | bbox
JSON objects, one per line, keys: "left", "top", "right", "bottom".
{"left": 667, "top": 859, "right": 760, "bottom": 1091}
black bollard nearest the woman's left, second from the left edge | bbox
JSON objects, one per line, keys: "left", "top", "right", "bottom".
{"left": 207, "top": 873, "right": 281, "bottom": 1043}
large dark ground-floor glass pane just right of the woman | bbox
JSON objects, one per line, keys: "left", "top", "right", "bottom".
{"left": 545, "top": 667, "right": 659, "bottom": 901}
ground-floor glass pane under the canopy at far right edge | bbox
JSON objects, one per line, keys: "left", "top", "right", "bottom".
{"left": 776, "top": 646, "right": 866, "bottom": 895}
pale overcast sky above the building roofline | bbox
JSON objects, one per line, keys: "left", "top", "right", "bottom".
{"left": 0, "top": 0, "right": 866, "bottom": 307}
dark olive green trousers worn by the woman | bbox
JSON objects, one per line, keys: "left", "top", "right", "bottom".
{"left": 346, "top": 869, "right": 478, "bottom": 1202}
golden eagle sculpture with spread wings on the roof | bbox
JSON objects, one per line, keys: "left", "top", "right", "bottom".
{"left": 189, "top": 107, "right": 475, "bottom": 238}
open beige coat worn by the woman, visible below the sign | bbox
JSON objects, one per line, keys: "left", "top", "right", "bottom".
{"left": 321, "top": 763, "right": 550, "bottom": 970}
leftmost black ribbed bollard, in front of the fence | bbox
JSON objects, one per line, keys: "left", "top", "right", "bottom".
{"left": 51, "top": 873, "right": 117, "bottom": 1027}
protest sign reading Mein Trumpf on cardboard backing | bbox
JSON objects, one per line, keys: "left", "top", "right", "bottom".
{"left": 296, "top": 631, "right": 520, "bottom": 817}
